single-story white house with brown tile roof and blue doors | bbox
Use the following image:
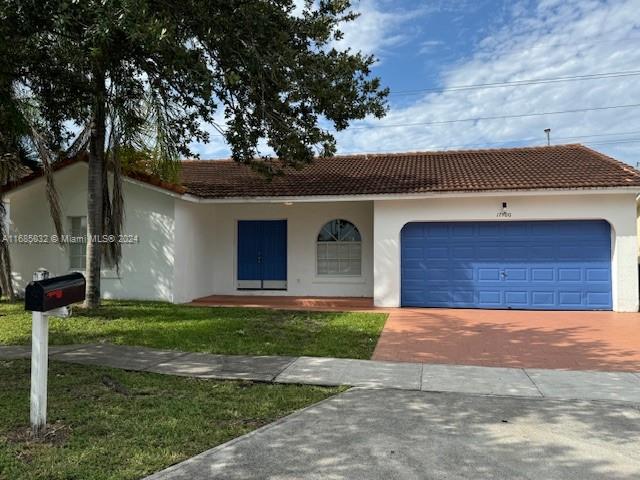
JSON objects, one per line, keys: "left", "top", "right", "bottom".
{"left": 5, "top": 145, "right": 640, "bottom": 312}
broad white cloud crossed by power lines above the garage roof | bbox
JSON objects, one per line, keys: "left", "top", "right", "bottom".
{"left": 338, "top": 0, "right": 640, "bottom": 164}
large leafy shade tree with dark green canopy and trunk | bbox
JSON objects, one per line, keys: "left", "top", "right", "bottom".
{"left": 0, "top": 0, "right": 388, "bottom": 307}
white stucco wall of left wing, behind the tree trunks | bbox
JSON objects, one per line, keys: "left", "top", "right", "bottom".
{"left": 7, "top": 163, "right": 174, "bottom": 301}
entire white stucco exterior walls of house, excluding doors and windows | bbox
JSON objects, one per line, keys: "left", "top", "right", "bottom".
{"left": 6, "top": 163, "right": 638, "bottom": 311}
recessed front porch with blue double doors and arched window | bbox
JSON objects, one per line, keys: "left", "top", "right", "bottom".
{"left": 171, "top": 201, "right": 373, "bottom": 304}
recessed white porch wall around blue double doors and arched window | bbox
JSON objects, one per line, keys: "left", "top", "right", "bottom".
{"left": 176, "top": 202, "right": 373, "bottom": 301}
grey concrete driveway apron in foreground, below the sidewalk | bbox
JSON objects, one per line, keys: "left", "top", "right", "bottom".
{"left": 148, "top": 389, "right": 640, "bottom": 480}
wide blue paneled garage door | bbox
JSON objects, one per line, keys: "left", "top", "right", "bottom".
{"left": 401, "top": 221, "right": 612, "bottom": 310}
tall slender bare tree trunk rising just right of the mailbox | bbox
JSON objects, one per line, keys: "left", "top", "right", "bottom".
{"left": 85, "top": 72, "right": 105, "bottom": 308}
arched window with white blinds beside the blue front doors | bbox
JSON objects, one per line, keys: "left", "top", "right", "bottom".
{"left": 316, "top": 219, "right": 362, "bottom": 276}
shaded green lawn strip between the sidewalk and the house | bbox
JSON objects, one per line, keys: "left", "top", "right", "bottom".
{"left": 0, "top": 301, "right": 386, "bottom": 359}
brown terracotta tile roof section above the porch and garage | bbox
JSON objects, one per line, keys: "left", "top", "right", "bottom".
{"left": 182, "top": 145, "right": 640, "bottom": 198}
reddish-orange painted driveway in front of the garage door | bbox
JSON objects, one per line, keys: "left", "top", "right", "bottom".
{"left": 373, "top": 308, "right": 640, "bottom": 371}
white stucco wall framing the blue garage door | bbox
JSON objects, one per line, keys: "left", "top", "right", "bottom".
{"left": 373, "top": 193, "right": 638, "bottom": 312}
